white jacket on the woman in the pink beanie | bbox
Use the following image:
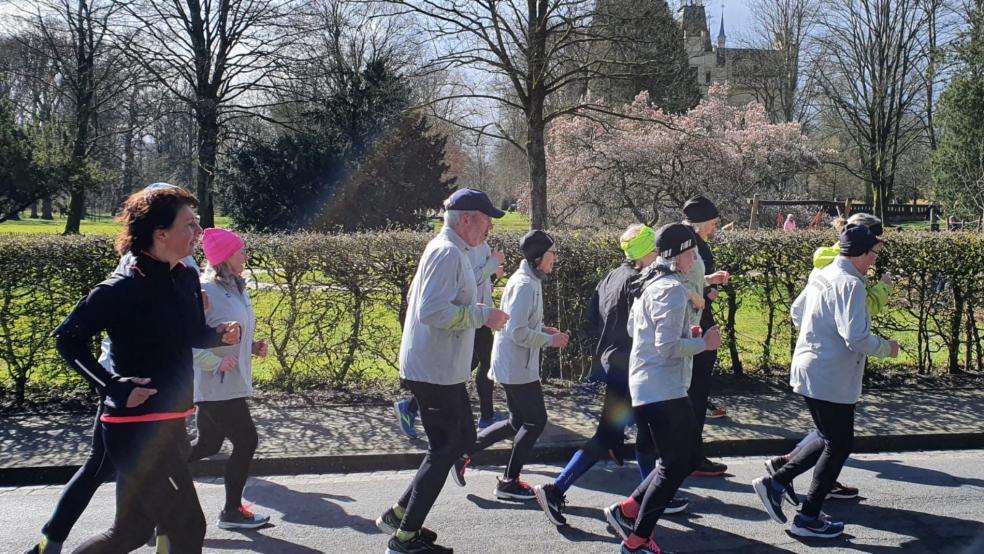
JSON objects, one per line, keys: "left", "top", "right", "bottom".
{"left": 194, "top": 281, "right": 256, "bottom": 403}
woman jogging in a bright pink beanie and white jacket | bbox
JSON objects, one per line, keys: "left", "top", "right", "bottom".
{"left": 189, "top": 228, "right": 270, "bottom": 529}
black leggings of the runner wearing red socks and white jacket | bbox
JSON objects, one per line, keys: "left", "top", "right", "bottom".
{"left": 632, "top": 396, "right": 700, "bottom": 538}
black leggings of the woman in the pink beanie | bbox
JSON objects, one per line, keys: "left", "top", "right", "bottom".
{"left": 189, "top": 398, "right": 257, "bottom": 510}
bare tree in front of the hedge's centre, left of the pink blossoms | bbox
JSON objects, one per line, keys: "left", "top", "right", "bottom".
{"left": 381, "top": 0, "right": 664, "bottom": 228}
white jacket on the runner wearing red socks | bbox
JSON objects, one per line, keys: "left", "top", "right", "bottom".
{"left": 628, "top": 259, "right": 704, "bottom": 406}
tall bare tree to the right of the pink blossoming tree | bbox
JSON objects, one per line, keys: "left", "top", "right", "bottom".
{"left": 818, "top": 0, "right": 927, "bottom": 220}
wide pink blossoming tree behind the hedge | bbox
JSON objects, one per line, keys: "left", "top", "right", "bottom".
{"left": 547, "top": 85, "right": 823, "bottom": 226}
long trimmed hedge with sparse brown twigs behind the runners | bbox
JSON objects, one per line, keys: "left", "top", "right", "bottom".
{"left": 0, "top": 227, "right": 984, "bottom": 402}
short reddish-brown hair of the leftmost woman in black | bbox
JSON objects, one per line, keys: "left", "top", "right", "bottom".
{"left": 116, "top": 187, "right": 198, "bottom": 256}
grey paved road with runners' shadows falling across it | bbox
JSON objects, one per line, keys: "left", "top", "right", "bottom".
{"left": 0, "top": 450, "right": 984, "bottom": 554}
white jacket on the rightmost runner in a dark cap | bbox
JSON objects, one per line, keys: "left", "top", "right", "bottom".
{"left": 789, "top": 256, "right": 891, "bottom": 404}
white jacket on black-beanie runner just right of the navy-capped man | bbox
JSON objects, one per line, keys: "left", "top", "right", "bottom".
{"left": 489, "top": 260, "right": 553, "bottom": 385}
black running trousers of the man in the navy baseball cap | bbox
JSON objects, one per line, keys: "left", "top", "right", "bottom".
{"left": 397, "top": 381, "right": 475, "bottom": 532}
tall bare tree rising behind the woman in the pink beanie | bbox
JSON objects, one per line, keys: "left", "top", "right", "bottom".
{"left": 113, "top": 0, "right": 302, "bottom": 226}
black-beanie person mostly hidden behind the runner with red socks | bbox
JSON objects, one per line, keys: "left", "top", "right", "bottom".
{"left": 683, "top": 196, "right": 731, "bottom": 477}
